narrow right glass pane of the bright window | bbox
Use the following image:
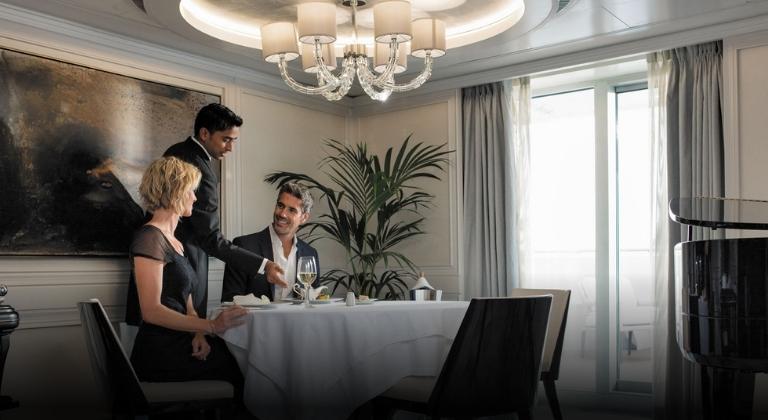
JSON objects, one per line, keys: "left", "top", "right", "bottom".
{"left": 614, "top": 84, "right": 654, "bottom": 391}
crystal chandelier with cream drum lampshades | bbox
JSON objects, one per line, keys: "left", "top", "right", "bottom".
{"left": 261, "top": 0, "right": 446, "bottom": 101}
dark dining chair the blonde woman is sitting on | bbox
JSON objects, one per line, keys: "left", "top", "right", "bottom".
{"left": 77, "top": 299, "right": 234, "bottom": 418}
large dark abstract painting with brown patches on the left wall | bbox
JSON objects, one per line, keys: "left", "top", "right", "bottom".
{"left": 0, "top": 49, "right": 220, "bottom": 255}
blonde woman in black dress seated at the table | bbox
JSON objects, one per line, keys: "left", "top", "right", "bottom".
{"left": 129, "top": 157, "right": 247, "bottom": 391}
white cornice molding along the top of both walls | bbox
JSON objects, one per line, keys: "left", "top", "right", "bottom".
{"left": 0, "top": 0, "right": 768, "bottom": 110}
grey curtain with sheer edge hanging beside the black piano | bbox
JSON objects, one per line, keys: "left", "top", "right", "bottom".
{"left": 649, "top": 41, "right": 725, "bottom": 419}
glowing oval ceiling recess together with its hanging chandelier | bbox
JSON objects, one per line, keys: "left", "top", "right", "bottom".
{"left": 179, "top": 0, "right": 525, "bottom": 101}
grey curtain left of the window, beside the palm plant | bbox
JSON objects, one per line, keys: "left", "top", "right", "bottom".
{"left": 462, "top": 82, "right": 519, "bottom": 298}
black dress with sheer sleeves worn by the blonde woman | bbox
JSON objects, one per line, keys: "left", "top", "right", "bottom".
{"left": 129, "top": 225, "right": 243, "bottom": 388}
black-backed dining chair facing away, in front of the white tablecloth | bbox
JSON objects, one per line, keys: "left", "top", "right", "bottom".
{"left": 372, "top": 296, "right": 552, "bottom": 419}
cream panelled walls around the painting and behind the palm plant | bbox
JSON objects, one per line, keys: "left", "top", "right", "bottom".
{"left": 0, "top": 4, "right": 460, "bottom": 410}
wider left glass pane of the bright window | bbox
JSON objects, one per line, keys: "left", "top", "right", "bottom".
{"left": 524, "top": 89, "right": 596, "bottom": 389}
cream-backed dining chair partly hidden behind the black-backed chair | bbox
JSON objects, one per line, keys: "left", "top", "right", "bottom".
{"left": 510, "top": 289, "right": 571, "bottom": 420}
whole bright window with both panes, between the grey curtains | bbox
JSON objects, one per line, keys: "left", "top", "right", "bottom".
{"left": 523, "top": 74, "right": 654, "bottom": 392}
